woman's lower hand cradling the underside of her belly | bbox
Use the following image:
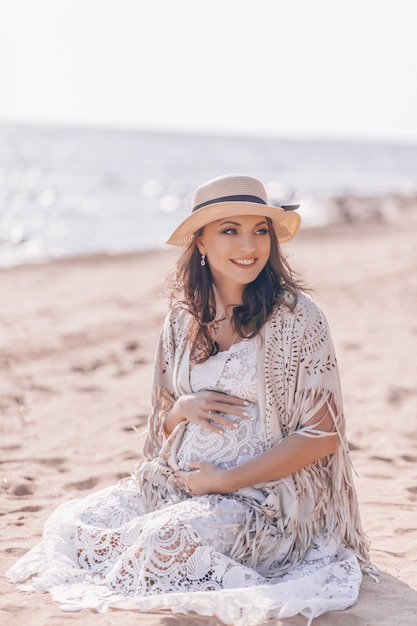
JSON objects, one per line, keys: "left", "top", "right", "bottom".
{"left": 175, "top": 461, "right": 228, "bottom": 496}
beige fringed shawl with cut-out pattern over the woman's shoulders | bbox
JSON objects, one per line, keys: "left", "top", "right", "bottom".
{"left": 141, "top": 293, "right": 369, "bottom": 576}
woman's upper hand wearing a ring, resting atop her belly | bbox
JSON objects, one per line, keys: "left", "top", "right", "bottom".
{"left": 165, "top": 390, "right": 248, "bottom": 434}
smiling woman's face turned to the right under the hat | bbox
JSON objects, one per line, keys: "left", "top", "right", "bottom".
{"left": 197, "top": 215, "right": 271, "bottom": 290}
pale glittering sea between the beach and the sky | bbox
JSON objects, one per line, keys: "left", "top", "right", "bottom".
{"left": 0, "top": 124, "right": 417, "bottom": 268}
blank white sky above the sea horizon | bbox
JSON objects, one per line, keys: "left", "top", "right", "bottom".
{"left": 0, "top": 0, "right": 417, "bottom": 143}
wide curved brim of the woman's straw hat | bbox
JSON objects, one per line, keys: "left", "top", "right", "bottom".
{"left": 166, "top": 202, "right": 301, "bottom": 247}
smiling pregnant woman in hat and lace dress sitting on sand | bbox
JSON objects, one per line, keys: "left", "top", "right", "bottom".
{"left": 8, "top": 175, "right": 370, "bottom": 625}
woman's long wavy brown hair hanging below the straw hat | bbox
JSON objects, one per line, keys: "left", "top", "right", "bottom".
{"left": 167, "top": 218, "right": 306, "bottom": 363}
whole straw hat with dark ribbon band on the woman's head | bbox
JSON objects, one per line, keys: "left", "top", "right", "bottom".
{"left": 167, "top": 174, "right": 301, "bottom": 247}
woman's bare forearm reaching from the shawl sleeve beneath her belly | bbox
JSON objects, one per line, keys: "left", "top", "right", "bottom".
{"left": 222, "top": 433, "right": 338, "bottom": 493}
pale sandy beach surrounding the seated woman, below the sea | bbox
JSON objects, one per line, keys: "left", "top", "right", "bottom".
{"left": 0, "top": 206, "right": 417, "bottom": 626}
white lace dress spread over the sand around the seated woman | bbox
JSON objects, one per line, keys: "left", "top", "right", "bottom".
{"left": 8, "top": 338, "right": 361, "bottom": 626}
